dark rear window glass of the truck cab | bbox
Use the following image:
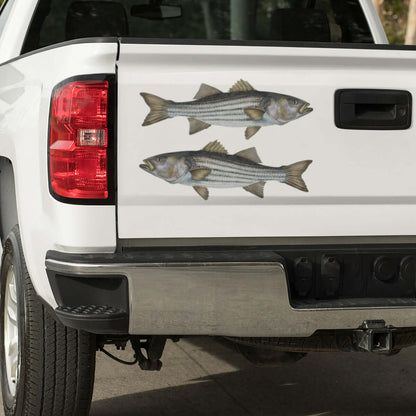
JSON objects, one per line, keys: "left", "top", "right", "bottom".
{"left": 22, "top": 0, "right": 373, "bottom": 53}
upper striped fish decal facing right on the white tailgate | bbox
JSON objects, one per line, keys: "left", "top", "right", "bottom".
{"left": 140, "top": 80, "right": 313, "bottom": 139}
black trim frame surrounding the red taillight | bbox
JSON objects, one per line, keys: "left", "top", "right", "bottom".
{"left": 47, "top": 74, "right": 117, "bottom": 205}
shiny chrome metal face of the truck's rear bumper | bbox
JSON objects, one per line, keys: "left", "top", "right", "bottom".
{"left": 46, "top": 253, "right": 416, "bottom": 337}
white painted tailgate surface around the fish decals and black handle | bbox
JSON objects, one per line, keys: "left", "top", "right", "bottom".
{"left": 117, "top": 41, "right": 416, "bottom": 239}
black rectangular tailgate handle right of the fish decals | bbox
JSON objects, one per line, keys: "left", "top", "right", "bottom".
{"left": 335, "top": 89, "right": 412, "bottom": 130}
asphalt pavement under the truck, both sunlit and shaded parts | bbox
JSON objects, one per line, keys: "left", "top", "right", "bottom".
{"left": 1, "top": 338, "right": 416, "bottom": 416}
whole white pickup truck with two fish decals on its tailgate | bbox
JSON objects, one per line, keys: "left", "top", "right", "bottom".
{"left": 0, "top": 0, "right": 416, "bottom": 416}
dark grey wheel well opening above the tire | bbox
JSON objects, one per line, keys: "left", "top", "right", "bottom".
{"left": 0, "top": 157, "right": 18, "bottom": 243}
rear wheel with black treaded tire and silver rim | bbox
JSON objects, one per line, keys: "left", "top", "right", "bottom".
{"left": 0, "top": 227, "right": 96, "bottom": 416}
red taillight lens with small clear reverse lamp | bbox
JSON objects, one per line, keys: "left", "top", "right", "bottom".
{"left": 49, "top": 81, "right": 109, "bottom": 199}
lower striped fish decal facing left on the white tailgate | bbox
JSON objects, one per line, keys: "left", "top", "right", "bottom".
{"left": 140, "top": 141, "right": 312, "bottom": 200}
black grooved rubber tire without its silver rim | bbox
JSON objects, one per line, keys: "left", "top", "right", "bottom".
{"left": 0, "top": 228, "right": 96, "bottom": 416}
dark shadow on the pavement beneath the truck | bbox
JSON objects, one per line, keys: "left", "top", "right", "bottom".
{"left": 91, "top": 340, "right": 416, "bottom": 416}
